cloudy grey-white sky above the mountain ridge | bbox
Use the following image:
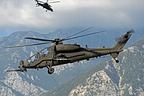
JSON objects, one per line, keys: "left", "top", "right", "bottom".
{"left": 0, "top": 0, "right": 144, "bottom": 36}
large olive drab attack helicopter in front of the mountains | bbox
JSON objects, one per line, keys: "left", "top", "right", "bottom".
{"left": 8, "top": 28, "right": 133, "bottom": 74}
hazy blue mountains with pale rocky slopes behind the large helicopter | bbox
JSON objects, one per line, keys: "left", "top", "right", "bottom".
{"left": 0, "top": 29, "right": 144, "bottom": 96}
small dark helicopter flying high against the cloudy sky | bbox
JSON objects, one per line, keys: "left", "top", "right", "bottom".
{"left": 35, "top": 0, "right": 60, "bottom": 12}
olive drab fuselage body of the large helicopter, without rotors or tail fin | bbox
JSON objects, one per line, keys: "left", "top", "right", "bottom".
{"left": 24, "top": 44, "right": 119, "bottom": 68}
